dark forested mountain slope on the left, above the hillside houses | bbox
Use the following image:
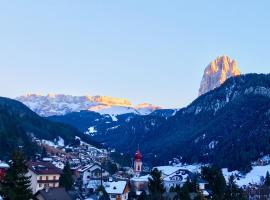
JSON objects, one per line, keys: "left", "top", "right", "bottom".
{"left": 0, "top": 97, "right": 98, "bottom": 158}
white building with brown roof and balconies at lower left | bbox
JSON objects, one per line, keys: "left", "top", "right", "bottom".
{"left": 27, "top": 162, "right": 62, "bottom": 194}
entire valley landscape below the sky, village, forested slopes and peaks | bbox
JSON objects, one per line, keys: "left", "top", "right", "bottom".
{"left": 0, "top": 56, "right": 270, "bottom": 200}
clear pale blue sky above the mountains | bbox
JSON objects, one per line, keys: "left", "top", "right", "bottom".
{"left": 0, "top": 0, "right": 270, "bottom": 107}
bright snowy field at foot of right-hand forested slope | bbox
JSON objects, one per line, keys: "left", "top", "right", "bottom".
{"left": 222, "top": 165, "right": 270, "bottom": 187}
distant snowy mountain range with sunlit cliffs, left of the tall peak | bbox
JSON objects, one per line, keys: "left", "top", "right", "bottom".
{"left": 16, "top": 94, "right": 161, "bottom": 117}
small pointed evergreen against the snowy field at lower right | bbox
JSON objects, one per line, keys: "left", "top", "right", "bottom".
{"left": 224, "top": 175, "right": 247, "bottom": 200}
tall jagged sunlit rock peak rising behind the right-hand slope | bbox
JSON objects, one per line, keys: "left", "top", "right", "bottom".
{"left": 199, "top": 56, "right": 240, "bottom": 96}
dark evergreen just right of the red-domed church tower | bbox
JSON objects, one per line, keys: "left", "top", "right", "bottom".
{"left": 148, "top": 168, "right": 165, "bottom": 200}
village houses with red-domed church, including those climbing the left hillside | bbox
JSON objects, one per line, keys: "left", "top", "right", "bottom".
{"left": 0, "top": 140, "right": 213, "bottom": 200}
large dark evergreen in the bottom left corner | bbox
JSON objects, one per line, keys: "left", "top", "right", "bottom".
{"left": 0, "top": 151, "right": 32, "bottom": 200}
